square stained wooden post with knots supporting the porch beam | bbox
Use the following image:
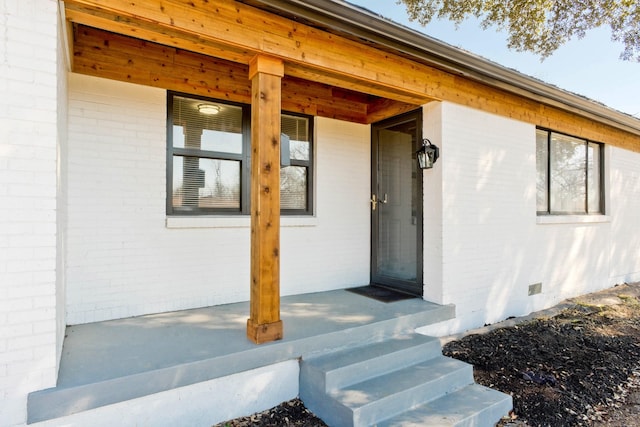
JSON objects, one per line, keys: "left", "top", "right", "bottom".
{"left": 247, "top": 55, "right": 284, "bottom": 344}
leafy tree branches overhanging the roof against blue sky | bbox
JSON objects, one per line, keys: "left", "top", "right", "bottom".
{"left": 398, "top": 0, "right": 640, "bottom": 62}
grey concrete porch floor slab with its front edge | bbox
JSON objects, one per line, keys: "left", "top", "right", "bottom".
{"left": 28, "top": 290, "right": 454, "bottom": 423}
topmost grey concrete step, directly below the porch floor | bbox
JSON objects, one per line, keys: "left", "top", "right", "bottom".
{"left": 300, "top": 334, "right": 441, "bottom": 393}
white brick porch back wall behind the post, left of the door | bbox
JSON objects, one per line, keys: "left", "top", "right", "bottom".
{"left": 66, "top": 75, "right": 370, "bottom": 324}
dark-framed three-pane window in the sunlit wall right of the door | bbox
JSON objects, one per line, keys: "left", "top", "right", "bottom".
{"left": 536, "top": 129, "right": 604, "bottom": 215}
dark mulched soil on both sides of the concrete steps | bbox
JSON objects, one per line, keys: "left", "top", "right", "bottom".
{"left": 218, "top": 284, "right": 640, "bottom": 427}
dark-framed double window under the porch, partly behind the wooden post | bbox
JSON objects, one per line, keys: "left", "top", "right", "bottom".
{"left": 167, "top": 92, "right": 313, "bottom": 215}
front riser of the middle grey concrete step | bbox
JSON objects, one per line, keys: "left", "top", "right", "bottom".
{"left": 353, "top": 365, "right": 473, "bottom": 427}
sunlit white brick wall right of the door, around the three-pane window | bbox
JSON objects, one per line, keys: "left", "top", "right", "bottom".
{"left": 421, "top": 103, "right": 640, "bottom": 335}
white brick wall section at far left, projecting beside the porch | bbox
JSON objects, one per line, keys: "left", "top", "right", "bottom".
{"left": 0, "top": 0, "right": 59, "bottom": 426}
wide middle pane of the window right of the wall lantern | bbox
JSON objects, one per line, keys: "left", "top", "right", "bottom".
{"left": 550, "top": 133, "right": 586, "bottom": 213}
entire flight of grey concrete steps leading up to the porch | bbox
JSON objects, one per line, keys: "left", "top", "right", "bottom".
{"left": 300, "top": 334, "right": 512, "bottom": 427}
